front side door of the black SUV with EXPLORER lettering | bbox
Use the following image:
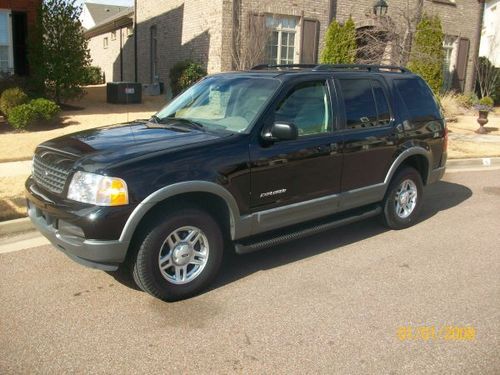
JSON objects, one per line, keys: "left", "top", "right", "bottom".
{"left": 250, "top": 77, "right": 342, "bottom": 229}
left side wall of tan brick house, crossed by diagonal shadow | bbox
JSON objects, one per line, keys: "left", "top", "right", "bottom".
{"left": 137, "top": 0, "right": 227, "bottom": 92}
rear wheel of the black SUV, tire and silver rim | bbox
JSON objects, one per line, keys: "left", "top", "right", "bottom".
{"left": 382, "top": 167, "right": 424, "bottom": 230}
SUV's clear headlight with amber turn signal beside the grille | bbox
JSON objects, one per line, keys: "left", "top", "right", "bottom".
{"left": 68, "top": 171, "right": 128, "bottom": 206}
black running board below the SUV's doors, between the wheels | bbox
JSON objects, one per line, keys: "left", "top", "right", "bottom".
{"left": 234, "top": 206, "right": 382, "bottom": 254}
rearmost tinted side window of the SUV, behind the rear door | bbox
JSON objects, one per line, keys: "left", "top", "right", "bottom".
{"left": 394, "top": 78, "right": 441, "bottom": 121}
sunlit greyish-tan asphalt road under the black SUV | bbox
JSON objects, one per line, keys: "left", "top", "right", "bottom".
{"left": 0, "top": 170, "right": 500, "bottom": 374}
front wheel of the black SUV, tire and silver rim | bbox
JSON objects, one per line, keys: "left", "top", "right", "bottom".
{"left": 132, "top": 208, "right": 224, "bottom": 302}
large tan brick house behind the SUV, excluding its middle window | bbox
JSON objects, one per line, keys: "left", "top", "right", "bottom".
{"left": 88, "top": 0, "right": 482, "bottom": 91}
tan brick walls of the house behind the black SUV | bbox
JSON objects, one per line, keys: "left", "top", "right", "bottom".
{"left": 131, "top": 0, "right": 481, "bottom": 93}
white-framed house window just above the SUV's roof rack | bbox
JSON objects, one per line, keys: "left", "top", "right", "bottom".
{"left": 266, "top": 16, "right": 298, "bottom": 64}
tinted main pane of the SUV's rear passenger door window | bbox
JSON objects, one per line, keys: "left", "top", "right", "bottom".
{"left": 339, "top": 79, "right": 377, "bottom": 129}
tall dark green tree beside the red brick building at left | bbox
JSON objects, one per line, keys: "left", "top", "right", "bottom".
{"left": 29, "top": 0, "right": 90, "bottom": 104}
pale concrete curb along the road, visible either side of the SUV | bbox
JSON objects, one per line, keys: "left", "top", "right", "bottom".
{"left": 0, "top": 157, "right": 500, "bottom": 237}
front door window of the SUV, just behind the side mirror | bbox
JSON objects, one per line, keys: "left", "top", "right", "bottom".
{"left": 274, "top": 81, "right": 332, "bottom": 136}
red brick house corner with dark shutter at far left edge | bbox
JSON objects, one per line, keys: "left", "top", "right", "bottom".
{"left": 0, "top": 0, "right": 42, "bottom": 76}
